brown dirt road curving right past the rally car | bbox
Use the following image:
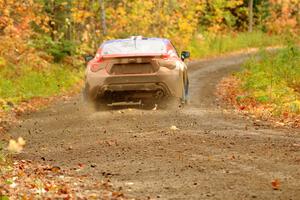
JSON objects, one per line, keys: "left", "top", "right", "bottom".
{"left": 10, "top": 55, "right": 300, "bottom": 200}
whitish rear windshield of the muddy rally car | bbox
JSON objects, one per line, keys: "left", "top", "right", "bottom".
{"left": 102, "top": 39, "right": 167, "bottom": 55}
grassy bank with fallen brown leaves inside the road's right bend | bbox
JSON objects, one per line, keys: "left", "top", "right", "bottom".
{"left": 217, "top": 45, "right": 300, "bottom": 128}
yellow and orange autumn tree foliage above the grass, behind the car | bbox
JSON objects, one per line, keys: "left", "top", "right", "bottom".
{"left": 0, "top": 0, "right": 300, "bottom": 63}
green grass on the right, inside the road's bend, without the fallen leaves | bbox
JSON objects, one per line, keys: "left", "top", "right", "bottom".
{"left": 237, "top": 46, "right": 300, "bottom": 115}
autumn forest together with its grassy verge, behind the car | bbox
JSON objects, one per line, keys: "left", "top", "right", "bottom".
{"left": 0, "top": 0, "right": 300, "bottom": 122}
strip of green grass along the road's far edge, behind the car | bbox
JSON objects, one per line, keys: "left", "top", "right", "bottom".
{"left": 188, "top": 31, "right": 296, "bottom": 58}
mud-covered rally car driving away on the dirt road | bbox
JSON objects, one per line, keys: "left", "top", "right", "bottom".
{"left": 84, "top": 36, "right": 190, "bottom": 106}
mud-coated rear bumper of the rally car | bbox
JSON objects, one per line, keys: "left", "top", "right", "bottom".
{"left": 86, "top": 69, "right": 183, "bottom": 99}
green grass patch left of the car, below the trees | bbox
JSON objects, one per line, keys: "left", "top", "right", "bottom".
{"left": 0, "top": 61, "right": 82, "bottom": 109}
